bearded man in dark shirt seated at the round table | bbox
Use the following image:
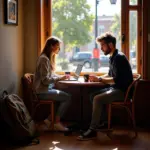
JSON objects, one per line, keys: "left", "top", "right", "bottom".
{"left": 77, "top": 33, "right": 133, "bottom": 140}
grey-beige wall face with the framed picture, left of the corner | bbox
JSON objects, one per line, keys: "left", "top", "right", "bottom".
{"left": 0, "top": 0, "right": 24, "bottom": 93}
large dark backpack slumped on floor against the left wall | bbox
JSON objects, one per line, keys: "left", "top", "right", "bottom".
{"left": 0, "top": 91, "right": 39, "bottom": 144}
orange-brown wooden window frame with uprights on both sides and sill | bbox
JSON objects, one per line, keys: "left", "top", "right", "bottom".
{"left": 38, "top": 0, "right": 148, "bottom": 79}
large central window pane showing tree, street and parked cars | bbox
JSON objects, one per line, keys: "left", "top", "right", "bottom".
{"left": 52, "top": 0, "right": 121, "bottom": 72}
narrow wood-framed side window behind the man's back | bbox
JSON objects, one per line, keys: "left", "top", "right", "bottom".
{"left": 125, "top": 0, "right": 142, "bottom": 73}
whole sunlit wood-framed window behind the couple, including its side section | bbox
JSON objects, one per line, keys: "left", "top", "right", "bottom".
{"left": 41, "top": 0, "right": 145, "bottom": 73}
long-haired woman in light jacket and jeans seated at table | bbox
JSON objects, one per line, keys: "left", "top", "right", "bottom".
{"left": 33, "top": 36, "right": 71, "bottom": 131}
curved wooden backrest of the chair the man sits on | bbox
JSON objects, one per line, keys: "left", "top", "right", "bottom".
{"left": 124, "top": 74, "right": 141, "bottom": 103}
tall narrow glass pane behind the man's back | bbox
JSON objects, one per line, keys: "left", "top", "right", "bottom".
{"left": 129, "top": 11, "right": 137, "bottom": 72}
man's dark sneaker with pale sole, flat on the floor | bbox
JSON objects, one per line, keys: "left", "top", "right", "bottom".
{"left": 77, "top": 129, "right": 97, "bottom": 141}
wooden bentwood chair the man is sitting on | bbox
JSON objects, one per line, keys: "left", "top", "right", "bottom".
{"left": 108, "top": 74, "right": 141, "bottom": 136}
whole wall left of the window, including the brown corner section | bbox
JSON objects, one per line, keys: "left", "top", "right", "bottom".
{"left": 0, "top": 0, "right": 38, "bottom": 94}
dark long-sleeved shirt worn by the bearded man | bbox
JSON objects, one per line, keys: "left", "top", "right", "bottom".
{"left": 108, "top": 49, "right": 133, "bottom": 92}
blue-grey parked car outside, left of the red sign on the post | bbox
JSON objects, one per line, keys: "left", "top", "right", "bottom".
{"left": 70, "top": 51, "right": 92, "bottom": 68}
